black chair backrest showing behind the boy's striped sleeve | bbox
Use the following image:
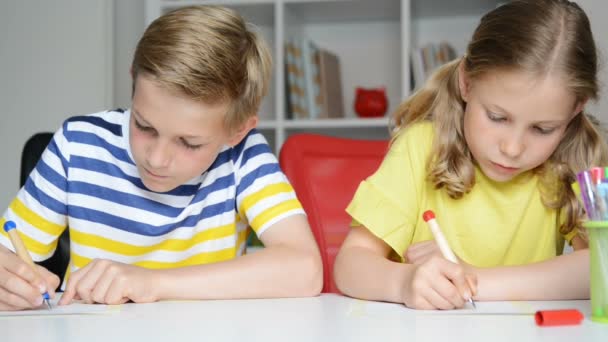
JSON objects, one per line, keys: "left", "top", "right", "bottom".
{"left": 19, "top": 132, "right": 70, "bottom": 288}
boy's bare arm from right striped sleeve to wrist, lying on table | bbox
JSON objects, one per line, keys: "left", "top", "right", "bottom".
{"left": 157, "top": 215, "right": 323, "bottom": 300}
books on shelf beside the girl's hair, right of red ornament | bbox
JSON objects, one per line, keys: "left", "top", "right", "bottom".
{"left": 411, "top": 42, "right": 456, "bottom": 88}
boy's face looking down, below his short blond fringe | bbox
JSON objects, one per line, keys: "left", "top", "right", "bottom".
{"left": 129, "top": 75, "right": 240, "bottom": 192}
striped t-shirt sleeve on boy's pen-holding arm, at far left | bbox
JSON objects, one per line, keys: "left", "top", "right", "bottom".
{"left": 0, "top": 123, "right": 69, "bottom": 261}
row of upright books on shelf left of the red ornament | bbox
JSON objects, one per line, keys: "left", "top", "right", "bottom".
{"left": 285, "top": 38, "right": 344, "bottom": 119}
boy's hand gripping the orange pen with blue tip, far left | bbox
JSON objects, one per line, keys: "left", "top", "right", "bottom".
{"left": 0, "top": 245, "right": 59, "bottom": 311}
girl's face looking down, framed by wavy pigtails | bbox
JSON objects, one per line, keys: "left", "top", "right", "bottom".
{"left": 460, "top": 67, "right": 584, "bottom": 182}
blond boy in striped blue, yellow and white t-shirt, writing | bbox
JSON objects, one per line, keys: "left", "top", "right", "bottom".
{"left": 0, "top": 6, "right": 322, "bottom": 310}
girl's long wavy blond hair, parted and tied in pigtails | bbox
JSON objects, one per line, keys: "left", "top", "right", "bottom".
{"left": 393, "top": 0, "right": 608, "bottom": 239}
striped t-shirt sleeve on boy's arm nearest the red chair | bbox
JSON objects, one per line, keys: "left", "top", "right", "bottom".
{"left": 236, "top": 132, "right": 304, "bottom": 236}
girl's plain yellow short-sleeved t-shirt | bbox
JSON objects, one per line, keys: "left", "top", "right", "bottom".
{"left": 346, "top": 122, "right": 564, "bottom": 267}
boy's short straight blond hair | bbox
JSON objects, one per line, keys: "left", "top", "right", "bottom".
{"left": 132, "top": 5, "right": 272, "bottom": 131}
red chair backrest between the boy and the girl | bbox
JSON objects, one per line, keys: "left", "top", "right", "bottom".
{"left": 279, "top": 134, "right": 388, "bottom": 293}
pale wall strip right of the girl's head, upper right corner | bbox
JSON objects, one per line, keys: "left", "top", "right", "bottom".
{"left": 577, "top": 0, "right": 608, "bottom": 126}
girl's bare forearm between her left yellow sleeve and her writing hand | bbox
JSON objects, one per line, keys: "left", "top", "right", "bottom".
{"left": 334, "top": 247, "right": 414, "bottom": 303}
